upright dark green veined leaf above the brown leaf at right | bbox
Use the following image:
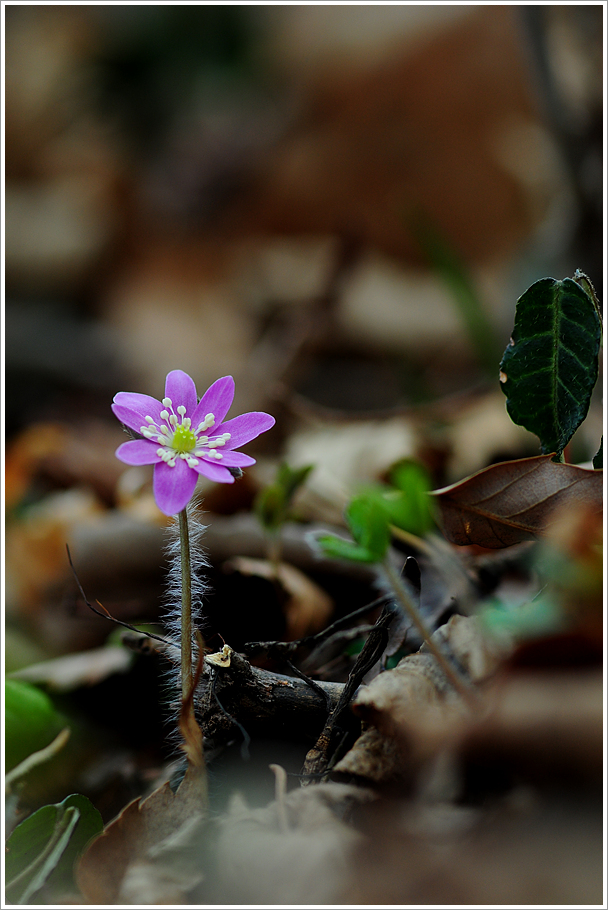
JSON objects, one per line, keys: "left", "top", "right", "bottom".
{"left": 500, "top": 278, "right": 601, "bottom": 455}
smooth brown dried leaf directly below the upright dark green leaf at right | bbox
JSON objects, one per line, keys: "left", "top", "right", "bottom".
{"left": 433, "top": 455, "right": 603, "bottom": 549}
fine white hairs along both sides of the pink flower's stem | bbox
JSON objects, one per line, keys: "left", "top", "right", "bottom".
{"left": 163, "top": 498, "right": 209, "bottom": 744}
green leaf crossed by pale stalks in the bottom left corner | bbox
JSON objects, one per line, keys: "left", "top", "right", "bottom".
{"left": 5, "top": 794, "right": 103, "bottom": 904}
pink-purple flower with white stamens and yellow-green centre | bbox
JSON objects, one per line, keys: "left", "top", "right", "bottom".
{"left": 112, "top": 370, "right": 275, "bottom": 515}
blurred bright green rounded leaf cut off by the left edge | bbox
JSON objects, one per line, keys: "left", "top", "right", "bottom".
{"left": 4, "top": 679, "right": 66, "bottom": 771}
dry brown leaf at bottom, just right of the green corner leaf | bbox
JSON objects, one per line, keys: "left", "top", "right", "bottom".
{"left": 75, "top": 765, "right": 205, "bottom": 906}
